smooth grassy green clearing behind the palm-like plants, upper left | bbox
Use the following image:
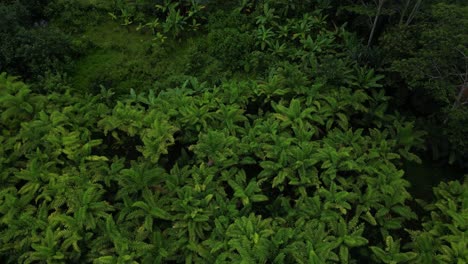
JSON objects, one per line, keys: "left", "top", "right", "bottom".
{"left": 72, "top": 21, "right": 198, "bottom": 93}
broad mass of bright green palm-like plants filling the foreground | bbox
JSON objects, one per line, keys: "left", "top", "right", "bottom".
{"left": 0, "top": 2, "right": 468, "bottom": 263}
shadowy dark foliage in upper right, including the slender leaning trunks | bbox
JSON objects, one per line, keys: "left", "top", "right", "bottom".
{"left": 338, "top": 0, "right": 468, "bottom": 168}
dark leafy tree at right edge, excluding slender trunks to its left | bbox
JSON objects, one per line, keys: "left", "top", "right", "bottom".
{"left": 381, "top": 3, "right": 468, "bottom": 166}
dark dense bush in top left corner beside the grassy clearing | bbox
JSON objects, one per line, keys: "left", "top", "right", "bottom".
{"left": 0, "top": 2, "right": 74, "bottom": 79}
